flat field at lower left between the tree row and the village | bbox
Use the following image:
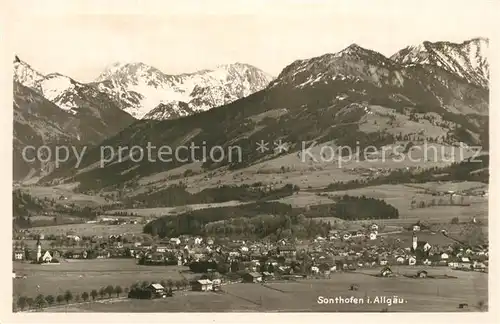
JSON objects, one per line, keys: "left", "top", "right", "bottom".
{"left": 13, "top": 259, "right": 193, "bottom": 298}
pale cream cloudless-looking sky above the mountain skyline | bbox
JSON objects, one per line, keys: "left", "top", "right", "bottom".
{"left": 8, "top": 0, "right": 495, "bottom": 81}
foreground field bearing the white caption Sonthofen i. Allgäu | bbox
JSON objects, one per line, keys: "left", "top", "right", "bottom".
{"left": 45, "top": 267, "right": 488, "bottom": 312}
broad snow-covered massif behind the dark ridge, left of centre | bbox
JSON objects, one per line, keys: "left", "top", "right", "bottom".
{"left": 96, "top": 63, "right": 272, "bottom": 118}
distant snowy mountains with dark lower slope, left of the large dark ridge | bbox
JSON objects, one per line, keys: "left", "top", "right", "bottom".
{"left": 14, "top": 56, "right": 272, "bottom": 179}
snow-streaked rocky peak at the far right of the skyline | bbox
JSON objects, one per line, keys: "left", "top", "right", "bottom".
{"left": 391, "top": 37, "right": 489, "bottom": 88}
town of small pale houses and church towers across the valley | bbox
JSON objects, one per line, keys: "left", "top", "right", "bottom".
{"left": 13, "top": 224, "right": 488, "bottom": 281}
